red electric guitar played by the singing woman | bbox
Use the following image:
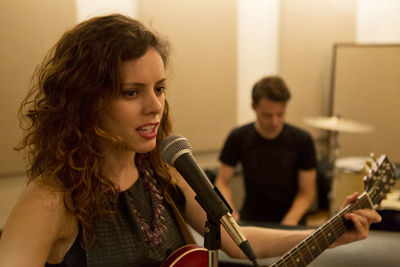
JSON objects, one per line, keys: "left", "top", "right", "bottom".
{"left": 161, "top": 155, "right": 399, "bottom": 267}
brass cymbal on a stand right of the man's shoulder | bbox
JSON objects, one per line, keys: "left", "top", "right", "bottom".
{"left": 304, "top": 116, "right": 373, "bottom": 133}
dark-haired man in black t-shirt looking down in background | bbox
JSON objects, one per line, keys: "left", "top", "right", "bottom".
{"left": 215, "top": 76, "right": 316, "bottom": 226}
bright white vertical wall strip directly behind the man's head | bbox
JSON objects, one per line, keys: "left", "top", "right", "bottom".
{"left": 237, "top": 0, "right": 279, "bottom": 124}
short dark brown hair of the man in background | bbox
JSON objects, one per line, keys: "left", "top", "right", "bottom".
{"left": 252, "top": 76, "right": 291, "bottom": 105}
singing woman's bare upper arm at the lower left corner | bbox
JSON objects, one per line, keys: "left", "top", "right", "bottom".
{"left": 0, "top": 182, "right": 77, "bottom": 267}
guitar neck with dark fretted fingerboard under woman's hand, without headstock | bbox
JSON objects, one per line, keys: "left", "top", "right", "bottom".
{"left": 269, "top": 192, "right": 372, "bottom": 267}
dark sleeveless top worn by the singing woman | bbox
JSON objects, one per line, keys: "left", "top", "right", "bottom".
{"left": 45, "top": 178, "right": 185, "bottom": 267}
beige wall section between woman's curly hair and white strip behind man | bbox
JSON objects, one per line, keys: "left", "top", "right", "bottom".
{"left": 139, "top": 0, "right": 237, "bottom": 152}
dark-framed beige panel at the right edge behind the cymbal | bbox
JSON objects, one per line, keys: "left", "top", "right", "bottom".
{"left": 334, "top": 44, "right": 400, "bottom": 163}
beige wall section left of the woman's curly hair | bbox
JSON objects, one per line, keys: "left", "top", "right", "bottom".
{"left": 0, "top": 0, "right": 75, "bottom": 178}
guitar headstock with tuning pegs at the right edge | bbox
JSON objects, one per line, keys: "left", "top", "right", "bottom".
{"left": 364, "top": 154, "right": 400, "bottom": 206}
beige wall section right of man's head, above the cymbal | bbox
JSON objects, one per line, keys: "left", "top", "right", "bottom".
{"left": 279, "top": 0, "right": 357, "bottom": 136}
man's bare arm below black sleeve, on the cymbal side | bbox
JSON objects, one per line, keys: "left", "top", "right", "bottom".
{"left": 281, "top": 169, "right": 317, "bottom": 225}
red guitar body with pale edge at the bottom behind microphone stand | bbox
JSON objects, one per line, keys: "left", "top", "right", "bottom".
{"left": 161, "top": 245, "right": 208, "bottom": 267}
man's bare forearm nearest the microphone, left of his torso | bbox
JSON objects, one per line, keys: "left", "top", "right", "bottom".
{"left": 215, "top": 163, "right": 239, "bottom": 221}
